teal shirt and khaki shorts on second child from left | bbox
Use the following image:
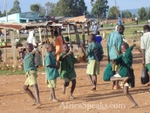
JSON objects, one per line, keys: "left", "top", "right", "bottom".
{"left": 44, "top": 52, "right": 59, "bottom": 88}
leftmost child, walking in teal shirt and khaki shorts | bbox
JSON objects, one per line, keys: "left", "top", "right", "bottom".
{"left": 23, "top": 43, "right": 41, "bottom": 108}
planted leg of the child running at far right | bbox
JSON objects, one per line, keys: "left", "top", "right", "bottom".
{"left": 124, "top": 86, "right": 138, "bottom": 108}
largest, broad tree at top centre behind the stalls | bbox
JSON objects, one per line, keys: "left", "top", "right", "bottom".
{"left": 55, "top": 0, "right": 87, "bottom": 17}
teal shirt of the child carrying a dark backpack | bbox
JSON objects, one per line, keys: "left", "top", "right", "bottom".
{"left": 86, "top": 42, "right": 104, "bottom": 60}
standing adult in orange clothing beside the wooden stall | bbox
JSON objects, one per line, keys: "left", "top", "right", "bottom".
{"left": 54, "top": 31, "right": 64, "bottom": 62}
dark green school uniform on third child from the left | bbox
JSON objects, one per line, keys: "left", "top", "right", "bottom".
{"left": 60, "top": 53, "right": 77, "bottom": 82}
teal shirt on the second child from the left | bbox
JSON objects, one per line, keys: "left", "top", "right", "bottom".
{"left": 44, "top": 52, "right": 59, "bottom": 80}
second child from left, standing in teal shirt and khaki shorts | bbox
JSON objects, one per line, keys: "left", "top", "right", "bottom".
{"left": 44, "top": 44, "right": 59, "bottom": 102}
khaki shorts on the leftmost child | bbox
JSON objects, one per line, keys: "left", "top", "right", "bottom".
{"left": 24, "top": 70, "right": 37, "bottom": 86}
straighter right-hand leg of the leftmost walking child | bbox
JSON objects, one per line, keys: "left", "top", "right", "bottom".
{"left": 32, "top": 84, "right": 41, "bottom": 107}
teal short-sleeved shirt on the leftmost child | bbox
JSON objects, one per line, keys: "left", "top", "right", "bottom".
{"left": 23, "top": 52, "right": 36, "bottom": 72}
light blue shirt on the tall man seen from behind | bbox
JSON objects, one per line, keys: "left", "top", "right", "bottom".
{"left": 107, "top": 31, "right": 123, "bottom": 60}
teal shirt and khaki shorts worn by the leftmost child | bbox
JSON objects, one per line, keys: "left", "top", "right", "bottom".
{"left": 23, "top": 52, "right": 37, "bottom": 86}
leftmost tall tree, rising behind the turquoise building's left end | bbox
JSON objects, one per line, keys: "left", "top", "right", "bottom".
{"left": 8, "top": 0, "right": 21, "bottom": 14}
